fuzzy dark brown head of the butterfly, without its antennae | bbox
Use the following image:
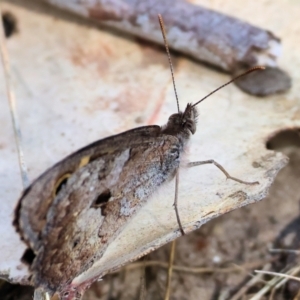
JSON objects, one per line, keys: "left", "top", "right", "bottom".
{"left": 162, "top": 104, "right": 198, "bottom": 144}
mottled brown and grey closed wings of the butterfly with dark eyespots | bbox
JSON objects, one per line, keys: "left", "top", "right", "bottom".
{"left": 15, "top": 126, "right": 181, "bottom": 292}
